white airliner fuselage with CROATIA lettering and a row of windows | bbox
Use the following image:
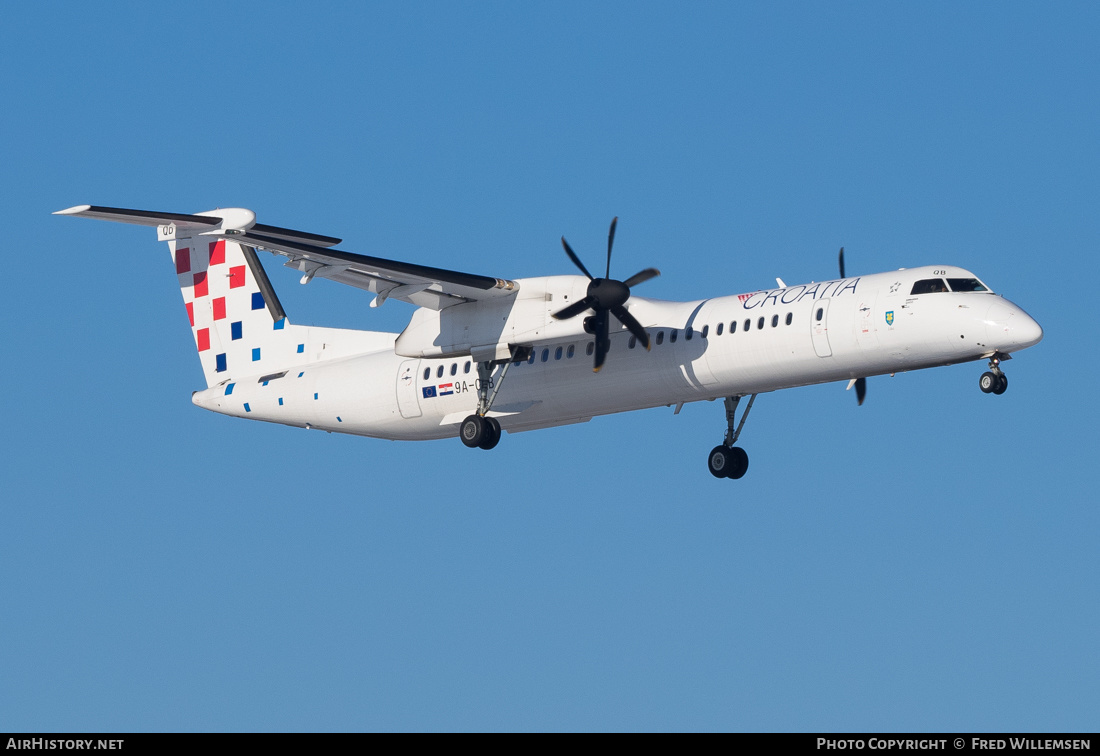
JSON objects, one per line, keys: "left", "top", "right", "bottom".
{"left": 193, "top": 266, "right": 1043, "bottom": 440}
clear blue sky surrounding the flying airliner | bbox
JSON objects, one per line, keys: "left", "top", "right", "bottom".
{"left": 0, "top": 2, "right": 1100, "bottom": 731}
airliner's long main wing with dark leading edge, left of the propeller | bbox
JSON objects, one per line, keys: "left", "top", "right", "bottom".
{"left": 234, "top": 232, "right": 519, "bottom": 310}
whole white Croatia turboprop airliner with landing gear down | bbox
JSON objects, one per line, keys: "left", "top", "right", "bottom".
{"left": 55, "top": 205, "right": 1043, "bottom": 479}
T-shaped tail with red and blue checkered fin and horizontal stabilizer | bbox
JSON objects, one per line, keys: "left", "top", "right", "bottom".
{"left": 55, "top": 205, "right": 394, "bottom": 387}
